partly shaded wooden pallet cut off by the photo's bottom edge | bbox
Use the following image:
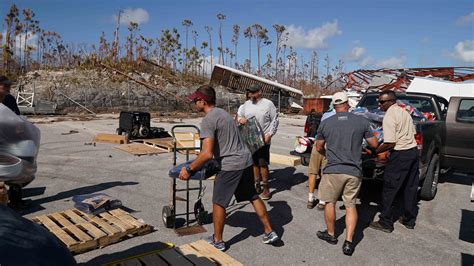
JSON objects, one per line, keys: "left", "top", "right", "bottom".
{"left": 105, "top": 240, "right": 242, "bottom": 266}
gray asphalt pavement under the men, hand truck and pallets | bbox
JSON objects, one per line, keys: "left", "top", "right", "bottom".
{"left": 20, "top": 117, "right": 474, "bottom": 265}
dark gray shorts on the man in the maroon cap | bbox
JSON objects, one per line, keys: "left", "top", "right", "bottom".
{"left": 212, "top": 166, "right": 258, "bottom": 208}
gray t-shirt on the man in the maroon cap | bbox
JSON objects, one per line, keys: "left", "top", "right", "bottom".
{"left": 201, "top": 107, "right": 253, "bottom": 171}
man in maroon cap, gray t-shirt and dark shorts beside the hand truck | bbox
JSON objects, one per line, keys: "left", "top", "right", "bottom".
{"left": 179, "top": 85, "right": 279, "bottom": 251}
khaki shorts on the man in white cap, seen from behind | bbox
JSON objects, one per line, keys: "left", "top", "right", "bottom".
{"left": 318, "top": 174, "right": 361, "bottom": 208}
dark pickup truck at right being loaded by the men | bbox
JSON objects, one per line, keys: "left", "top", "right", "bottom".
{"left": 291, "top": 93, "right": 474, "bottom": 200}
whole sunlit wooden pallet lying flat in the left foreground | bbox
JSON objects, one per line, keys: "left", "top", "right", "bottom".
{"left": 32, "top": 209, "right": 153, "bottom": 254}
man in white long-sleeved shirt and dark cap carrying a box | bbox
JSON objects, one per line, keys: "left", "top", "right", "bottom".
{"left": 237, "top": 85, "right": 279, "bottom": 200}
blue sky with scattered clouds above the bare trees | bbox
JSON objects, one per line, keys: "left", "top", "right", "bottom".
{"left": 0, "top": 0, "right": 474, "bottom": 71}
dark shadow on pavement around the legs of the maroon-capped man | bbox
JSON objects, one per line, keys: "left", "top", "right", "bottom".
{"left": 226, "top": 201, "right": 293, "bottom": 247}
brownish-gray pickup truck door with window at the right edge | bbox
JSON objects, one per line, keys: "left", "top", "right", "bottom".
{"left": 444, "top": 97, "right": 474, "bottom": 173}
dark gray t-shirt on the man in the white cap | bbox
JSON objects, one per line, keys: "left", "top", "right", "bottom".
{"left": 317, "top": 113, "right": 373, "bottom": 177}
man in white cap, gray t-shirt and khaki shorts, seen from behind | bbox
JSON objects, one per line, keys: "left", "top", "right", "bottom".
{"left": 316, "top": 92, "right": 378, "bottom": 255}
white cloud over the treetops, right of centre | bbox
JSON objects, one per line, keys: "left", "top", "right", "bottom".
{"left": 286, "top": 20, "right": 342, "bottom": 49}
